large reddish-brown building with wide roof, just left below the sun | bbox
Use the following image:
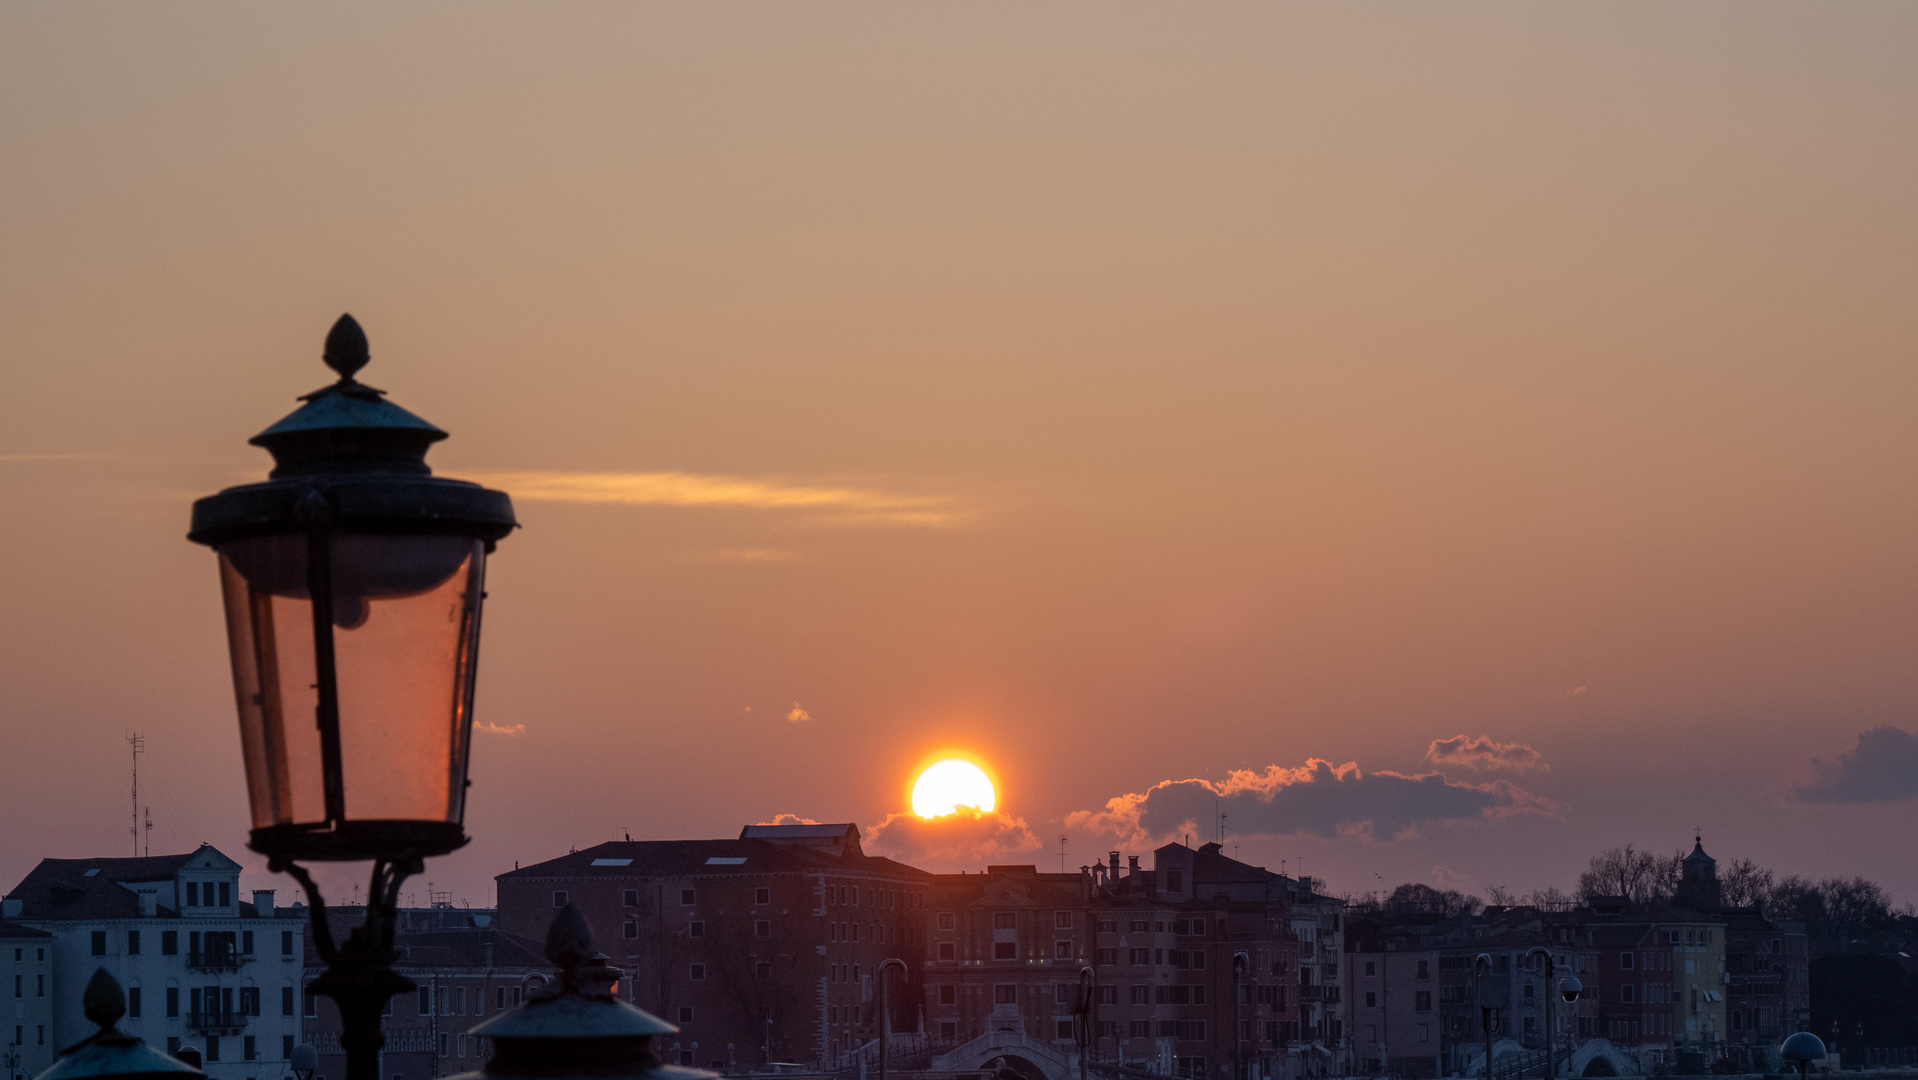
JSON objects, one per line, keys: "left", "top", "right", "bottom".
{"left": 497, "top": 825, "right": 932, "bottom": 1070}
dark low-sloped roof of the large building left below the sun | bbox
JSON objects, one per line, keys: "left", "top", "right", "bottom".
{"left": 495, "top": 838, "right": 932, "bottom": 880}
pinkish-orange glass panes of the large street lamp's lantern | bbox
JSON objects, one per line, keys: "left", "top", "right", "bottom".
{"left": 221, "top": 533, "right": 485, "bottom": 827}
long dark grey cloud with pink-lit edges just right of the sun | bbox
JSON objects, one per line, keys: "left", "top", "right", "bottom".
{"left": 1066, "top": 758, "right": 1557, "bottom": 846}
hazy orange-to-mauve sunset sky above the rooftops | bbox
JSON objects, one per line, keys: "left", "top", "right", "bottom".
{"left": 0, "top": 2, "right": 1918, "bottom": 905}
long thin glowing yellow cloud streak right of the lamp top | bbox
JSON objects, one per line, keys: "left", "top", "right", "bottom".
{"left": 458, "top": 472, "right": 971, "bottom": 528}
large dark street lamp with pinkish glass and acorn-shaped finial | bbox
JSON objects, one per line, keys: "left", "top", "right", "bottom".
{"left": 188, "top": 315, "right": 516, "bottom": 1080}
